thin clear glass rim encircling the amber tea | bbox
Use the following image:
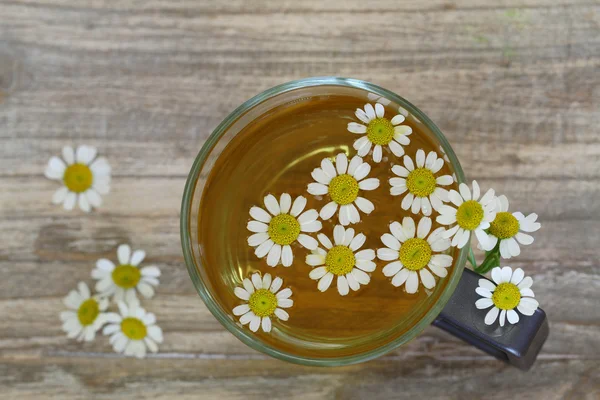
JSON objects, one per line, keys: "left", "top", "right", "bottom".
{"left": 180, "top": 76, "right": 468, "bottom": 366}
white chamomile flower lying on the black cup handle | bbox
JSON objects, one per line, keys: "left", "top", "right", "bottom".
{"left": 475, "top": 267, "right": 539, "bottom": 326}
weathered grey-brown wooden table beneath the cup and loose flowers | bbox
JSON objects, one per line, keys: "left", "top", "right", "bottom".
{"left": 0, "top": 0, "right": 600, "bottom": 400}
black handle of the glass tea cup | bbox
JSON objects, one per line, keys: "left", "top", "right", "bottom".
{"left": 433, "top": 269, "right": 548, "bottom": 370}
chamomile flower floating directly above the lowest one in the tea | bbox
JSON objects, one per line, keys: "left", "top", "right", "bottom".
{"left": 248, "top": 193, "right": 322, "bottom": 267}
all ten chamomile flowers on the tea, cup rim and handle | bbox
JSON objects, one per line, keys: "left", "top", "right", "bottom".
{"left": 233, "top": 103, "right": 540, "bottom": 332}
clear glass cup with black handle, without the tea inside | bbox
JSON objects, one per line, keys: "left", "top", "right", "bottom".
{"left": 181, "top": 77, "right": 548, "bottom": 369}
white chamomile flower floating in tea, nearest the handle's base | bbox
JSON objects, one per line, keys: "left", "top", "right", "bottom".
{"left": 377, "top": 217, "right": 452, "bottom": 294}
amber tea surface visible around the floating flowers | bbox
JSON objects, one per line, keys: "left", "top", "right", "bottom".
{"left": 199, "top": 93, "right": 457, "bottom": 357}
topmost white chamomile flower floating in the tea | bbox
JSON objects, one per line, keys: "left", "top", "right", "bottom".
{"left": 348, "top": 103, "right": 412, "bottom": 163}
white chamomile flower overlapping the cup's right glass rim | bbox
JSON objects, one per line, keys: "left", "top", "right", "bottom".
{"left": 436, "top": 181, "right": 496, "bottom": 249}
